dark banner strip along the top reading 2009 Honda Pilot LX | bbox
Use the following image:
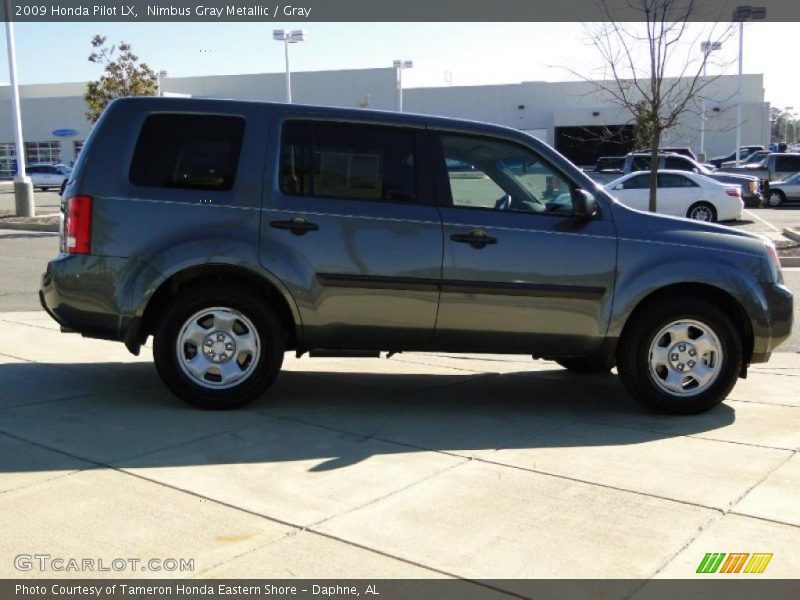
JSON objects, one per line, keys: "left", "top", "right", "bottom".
{"left": 0, "top": 0, "right": 800, "bottom": 23}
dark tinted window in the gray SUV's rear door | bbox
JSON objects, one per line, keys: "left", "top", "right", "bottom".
{"left": 280, "top": 121, "right": 417, "bottom": 202}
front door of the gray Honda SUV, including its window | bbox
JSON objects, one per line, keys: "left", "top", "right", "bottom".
{"left": 432, "top": 133, "right": 617, "bottom": 356}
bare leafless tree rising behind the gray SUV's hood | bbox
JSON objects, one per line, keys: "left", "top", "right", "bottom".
{"left": 570, "top": 0, "right": 733, "bottom": 211}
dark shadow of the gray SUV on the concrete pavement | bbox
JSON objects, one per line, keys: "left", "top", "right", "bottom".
{"left": 0, "top": 361, "right": 735, "bottom": 473}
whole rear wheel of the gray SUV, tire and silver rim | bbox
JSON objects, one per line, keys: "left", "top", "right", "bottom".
{"left": 153, "top": 281, "right": 286, "bottom": 410}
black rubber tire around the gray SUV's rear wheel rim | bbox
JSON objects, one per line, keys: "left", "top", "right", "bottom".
{"left": 153, "top": 285, "right": 285, "bottom": 410}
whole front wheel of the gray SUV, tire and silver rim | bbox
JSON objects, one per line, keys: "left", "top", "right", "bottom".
{"left": 617, "top": 296, "right": 743, "bottom": 414}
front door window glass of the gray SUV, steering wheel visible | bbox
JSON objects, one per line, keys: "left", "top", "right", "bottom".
{"left": 440, "top": 134, "right": 572, "bottom": 215}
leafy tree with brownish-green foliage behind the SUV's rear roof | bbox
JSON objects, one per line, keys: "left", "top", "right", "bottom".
{"left": 83, "top": 35, "right": 158, "bottom": 123}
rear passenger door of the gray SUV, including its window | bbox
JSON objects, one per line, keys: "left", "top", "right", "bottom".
{"left": 260, "top": 118, "right": 442, "bottom": 350}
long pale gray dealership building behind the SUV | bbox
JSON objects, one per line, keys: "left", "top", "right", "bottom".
{"left": 0, "top": 67, "right": 770, "bottom": 177}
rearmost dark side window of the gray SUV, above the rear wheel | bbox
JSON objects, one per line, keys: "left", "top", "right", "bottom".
{"left": 130, "top": 114, "right": 244, "bottom": 190}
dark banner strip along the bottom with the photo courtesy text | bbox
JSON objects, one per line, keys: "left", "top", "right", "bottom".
{"left": 0, "top": 580, "right": 800, "bottom": 600}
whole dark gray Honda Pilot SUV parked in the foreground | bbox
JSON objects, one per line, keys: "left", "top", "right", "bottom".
{"left": 41, "top": 98, "right": 792, "bottom": 413}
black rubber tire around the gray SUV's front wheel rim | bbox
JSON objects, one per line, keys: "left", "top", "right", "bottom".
{"left": 618, "top": 299, "right": 743, "bottom": 414}
